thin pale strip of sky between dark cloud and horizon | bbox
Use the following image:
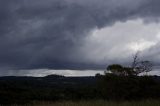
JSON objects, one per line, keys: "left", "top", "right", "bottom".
{"left": 3, "top": 69, "right": 160, "bottom": 77}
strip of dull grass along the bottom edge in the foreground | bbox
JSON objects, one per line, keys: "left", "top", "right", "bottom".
{"left": 4, "top": 100, "right": 160, "bottom": 106}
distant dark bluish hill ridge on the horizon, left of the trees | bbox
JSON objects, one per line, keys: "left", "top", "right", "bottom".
{"left": 0, "top": 75, "right": 96, "bottom": 87}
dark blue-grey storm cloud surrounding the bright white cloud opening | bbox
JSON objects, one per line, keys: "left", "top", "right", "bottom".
{"left": 0, "top": 0, "right": 160, "bottom": 69}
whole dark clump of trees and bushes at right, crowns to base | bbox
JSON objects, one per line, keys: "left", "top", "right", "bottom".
{"left": 98, "top": 53, "right": 160, "bottom": 101}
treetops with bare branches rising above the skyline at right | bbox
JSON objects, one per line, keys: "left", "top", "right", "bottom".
{"left": 105, "top": 52, "right": 152, "bottom": 76}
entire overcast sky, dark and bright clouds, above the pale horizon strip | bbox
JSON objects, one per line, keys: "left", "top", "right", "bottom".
{"left": 0, "top": 0, "right": 160, "bottom": 75}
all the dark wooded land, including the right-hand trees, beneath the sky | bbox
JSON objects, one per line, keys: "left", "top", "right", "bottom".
{"left": 0, "top": 54, "right": 160, "bottom": 106}
